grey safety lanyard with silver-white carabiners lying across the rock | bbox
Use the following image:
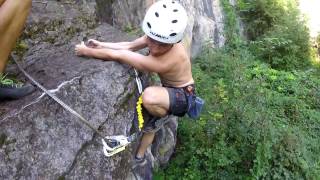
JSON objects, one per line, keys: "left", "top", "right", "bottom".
{"left": 12, "top": 55, "right": 143, "bottom": 157}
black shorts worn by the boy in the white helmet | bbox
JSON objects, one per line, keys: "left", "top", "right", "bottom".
{"left": 166, "top": 85, "right": 194, "bottom": 117}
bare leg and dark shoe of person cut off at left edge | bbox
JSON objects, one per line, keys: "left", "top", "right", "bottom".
{"left": 0, "top": 0, "right": 34, "bottom": 100}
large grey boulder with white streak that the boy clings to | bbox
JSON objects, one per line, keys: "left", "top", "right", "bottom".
{"left": 0, "top": 0, "right": 177, "bottom": 179}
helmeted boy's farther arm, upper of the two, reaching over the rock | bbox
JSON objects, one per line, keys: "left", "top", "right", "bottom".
{"left": 89, "top": 36, "right": 147, "bottom": 51}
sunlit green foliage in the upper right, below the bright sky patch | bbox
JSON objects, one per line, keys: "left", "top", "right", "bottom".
{"left": 238, "top": 0, "right": 310, "bottom": 70}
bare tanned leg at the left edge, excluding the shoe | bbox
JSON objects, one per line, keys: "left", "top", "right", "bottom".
{"left": 0, "top": 0, "right": 32, "bottom": 74}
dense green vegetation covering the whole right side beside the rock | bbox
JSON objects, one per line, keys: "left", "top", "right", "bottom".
{"left": 155, "top": 0, "right": 320, "bottom": 179}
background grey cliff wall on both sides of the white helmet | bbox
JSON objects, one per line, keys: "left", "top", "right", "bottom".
{"left": 97, "top": 0, "right": 225, "bottom": 57}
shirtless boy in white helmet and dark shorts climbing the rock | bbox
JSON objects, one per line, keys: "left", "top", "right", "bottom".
{"left": 75, "top": 0, "right": 194, "bottom": 161}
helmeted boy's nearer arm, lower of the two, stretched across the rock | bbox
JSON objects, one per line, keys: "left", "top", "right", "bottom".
{"left": 75, "top": 44, "right": 171, "bottom": 73}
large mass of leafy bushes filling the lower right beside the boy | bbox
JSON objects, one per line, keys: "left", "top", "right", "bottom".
{"left": 158, "top": 47, "right": 320, "bottom": 179}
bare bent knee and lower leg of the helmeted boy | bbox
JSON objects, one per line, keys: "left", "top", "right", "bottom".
{"left": 136, "top": 86, "right": 169, "bottom": 158}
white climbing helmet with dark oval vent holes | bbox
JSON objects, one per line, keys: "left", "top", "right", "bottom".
{"left": 142, "top": 0, "right": 188, "bottom": 44}
